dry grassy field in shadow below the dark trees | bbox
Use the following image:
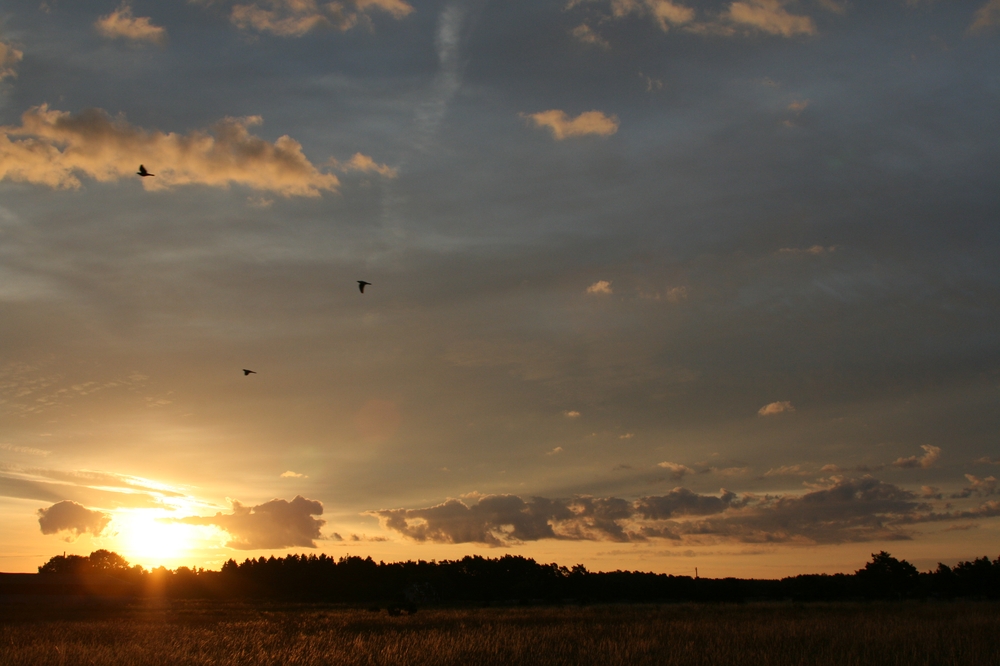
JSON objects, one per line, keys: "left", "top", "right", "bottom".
{"left": 0, "top": 601, "right": 1000, "bottom": 666}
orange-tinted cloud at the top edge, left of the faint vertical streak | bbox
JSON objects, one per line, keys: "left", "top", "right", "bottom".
{"left": 229, "top": 0, "right": 413, "bottom": 37}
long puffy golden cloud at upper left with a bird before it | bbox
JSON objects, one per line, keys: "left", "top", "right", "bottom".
{"left": 0, "top": 104, "right": 339, "bottom": 197}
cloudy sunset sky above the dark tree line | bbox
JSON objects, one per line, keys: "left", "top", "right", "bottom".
{"left": 0, "top": 0, "right": 1000, "bottom": 578}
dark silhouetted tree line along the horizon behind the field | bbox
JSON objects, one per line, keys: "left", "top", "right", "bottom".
{"left": 9, "top": 550, "right": 1000, "bottom": 609}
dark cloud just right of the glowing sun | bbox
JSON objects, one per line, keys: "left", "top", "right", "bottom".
{"left": 171, "top": 495, "right": 326, "bottom": 550}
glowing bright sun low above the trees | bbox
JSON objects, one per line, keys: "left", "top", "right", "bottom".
{"left": 114, "top": 509, "right": 198, "bottom": 568}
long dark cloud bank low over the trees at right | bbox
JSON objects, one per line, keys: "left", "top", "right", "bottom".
{"left": 369, "top": 477, "right": 944, "bottom": 546}
